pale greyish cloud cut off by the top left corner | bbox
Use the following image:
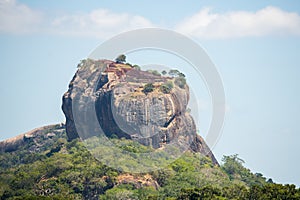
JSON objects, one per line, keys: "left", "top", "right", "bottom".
{"left": 0, "top": 0, "right": 43, "bottom": 34}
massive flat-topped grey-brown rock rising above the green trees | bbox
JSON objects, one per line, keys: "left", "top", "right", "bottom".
{"left": 62, "top": 59, "right": 217, "bottom": 164}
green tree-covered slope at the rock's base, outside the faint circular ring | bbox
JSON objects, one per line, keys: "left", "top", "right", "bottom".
{"left": 0, "top": 125, "right": 300, "bottom": 199}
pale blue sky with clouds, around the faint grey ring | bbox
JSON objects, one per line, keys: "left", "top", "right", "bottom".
{"left": 0, "top": 0, "right": 300, "bottom": 187}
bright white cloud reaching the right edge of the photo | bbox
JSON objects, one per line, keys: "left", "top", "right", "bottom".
{"left": 175, "top": 6, "right": 300, "bottom": 38}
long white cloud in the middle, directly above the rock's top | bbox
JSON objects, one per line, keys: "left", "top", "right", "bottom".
{"left": 50, "top": 9, "right": 154, "bottom": 38}
